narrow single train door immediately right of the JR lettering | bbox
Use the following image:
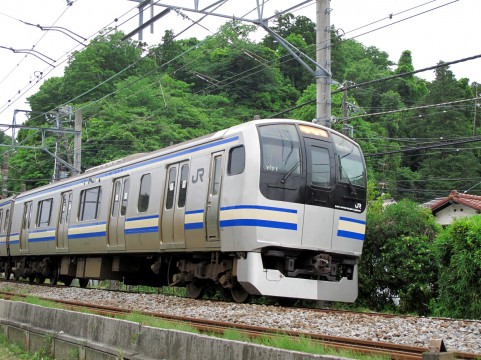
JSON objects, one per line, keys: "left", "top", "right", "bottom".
{"left": 206, "top": 152, "right": 223, "bottom": 241}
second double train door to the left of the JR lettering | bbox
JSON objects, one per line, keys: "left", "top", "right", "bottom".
{"left": 108, "top": 176, "right": 130, "bottom": 250}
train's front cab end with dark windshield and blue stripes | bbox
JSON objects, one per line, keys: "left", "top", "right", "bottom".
{"left": 231, "top": 120, "right": 366, "bottom": 302}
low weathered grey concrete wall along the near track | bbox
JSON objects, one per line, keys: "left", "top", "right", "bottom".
{"left": 0, "top": 300, "right": 339, "bottom": 360}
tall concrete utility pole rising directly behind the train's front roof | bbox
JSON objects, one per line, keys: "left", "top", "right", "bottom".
{"left": 316, "top": 0, "right": 332, "bottom": 127}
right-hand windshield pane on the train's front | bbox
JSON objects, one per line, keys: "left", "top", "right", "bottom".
{"left": 332, "top": 134, "right": 366, "bottom": 188}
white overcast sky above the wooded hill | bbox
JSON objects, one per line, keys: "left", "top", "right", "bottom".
{"left": 0, "top": 0, "right": 481, "bottom": 129}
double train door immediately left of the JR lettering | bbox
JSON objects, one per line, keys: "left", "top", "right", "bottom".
{"left": 161, "top": 162, "right": 189, "bottom": 247}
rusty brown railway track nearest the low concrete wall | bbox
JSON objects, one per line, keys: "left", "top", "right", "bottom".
{"left": 0, "top": 291, "right": 480, "bottom": 360}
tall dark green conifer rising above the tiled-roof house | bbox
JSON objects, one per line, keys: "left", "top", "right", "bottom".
{"left": 400, "top": 63, "right": 481, "bottom": 201}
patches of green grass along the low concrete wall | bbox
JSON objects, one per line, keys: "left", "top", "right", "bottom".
{"left": 0, "top": 296, "right": 389, "bottom": 360}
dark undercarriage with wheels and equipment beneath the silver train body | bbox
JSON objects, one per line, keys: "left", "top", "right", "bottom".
{"left": 0, "top": 249, "right": 356, "bottom": 303}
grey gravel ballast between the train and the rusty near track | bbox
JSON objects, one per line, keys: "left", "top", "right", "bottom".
{"left": 0, "top": 282, "right": 481, "bottom": 354}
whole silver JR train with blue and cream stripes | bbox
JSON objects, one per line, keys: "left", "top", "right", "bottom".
{"left": 0, "top": 119, "right": 367, "bottom": 303}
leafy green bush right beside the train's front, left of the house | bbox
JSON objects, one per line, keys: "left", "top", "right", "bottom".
{"left": 357, "top": 199, "right": 439, "bottom": 314}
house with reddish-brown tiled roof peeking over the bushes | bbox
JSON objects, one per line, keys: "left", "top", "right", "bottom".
{"left": 427, "top": 190, "right": 481, "bottom": 225}
